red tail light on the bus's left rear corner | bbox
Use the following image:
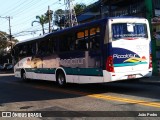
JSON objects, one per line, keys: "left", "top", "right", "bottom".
{"left": 106, "top": 56, "right": 114, "bottom": 72}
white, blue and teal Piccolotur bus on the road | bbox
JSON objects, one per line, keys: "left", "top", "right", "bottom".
{"left": 13, "top": 17, "right": 152, "bottom": 86}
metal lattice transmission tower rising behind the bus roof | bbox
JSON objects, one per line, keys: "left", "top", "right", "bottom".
{"left": 64, "top": 0, "right": 78, "bottom": 27}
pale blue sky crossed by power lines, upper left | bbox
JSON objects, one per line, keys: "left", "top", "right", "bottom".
{"left": 0, "top": 0, "right": 98, "bottom": 41}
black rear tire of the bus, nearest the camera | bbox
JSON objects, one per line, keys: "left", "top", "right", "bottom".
{"left": 56, "top": 72, "right": 66, "bottom": 87}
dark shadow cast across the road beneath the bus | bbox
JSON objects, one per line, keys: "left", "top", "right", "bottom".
{"left": 0, "top": 75, "right": 160, "bottom": 104}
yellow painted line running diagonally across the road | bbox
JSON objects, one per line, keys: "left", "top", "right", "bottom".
{"left": 3, "top": 81, "right": 160, "bottom": 108}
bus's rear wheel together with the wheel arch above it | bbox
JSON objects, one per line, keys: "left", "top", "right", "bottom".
{"left": 56, "top": 68, "right": 66, "bottom": 87}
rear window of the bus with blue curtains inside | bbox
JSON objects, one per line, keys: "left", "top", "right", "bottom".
{"left": 112, "top": 23, "right": 148, "bottom": 40}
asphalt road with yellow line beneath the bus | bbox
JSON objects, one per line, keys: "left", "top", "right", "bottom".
{"left": 0, "top": 74, "right": 160, "bottom": 120}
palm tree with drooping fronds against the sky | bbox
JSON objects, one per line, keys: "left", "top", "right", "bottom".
{"left": 32, "top": 15, "right": 48, "bottom": 35}
